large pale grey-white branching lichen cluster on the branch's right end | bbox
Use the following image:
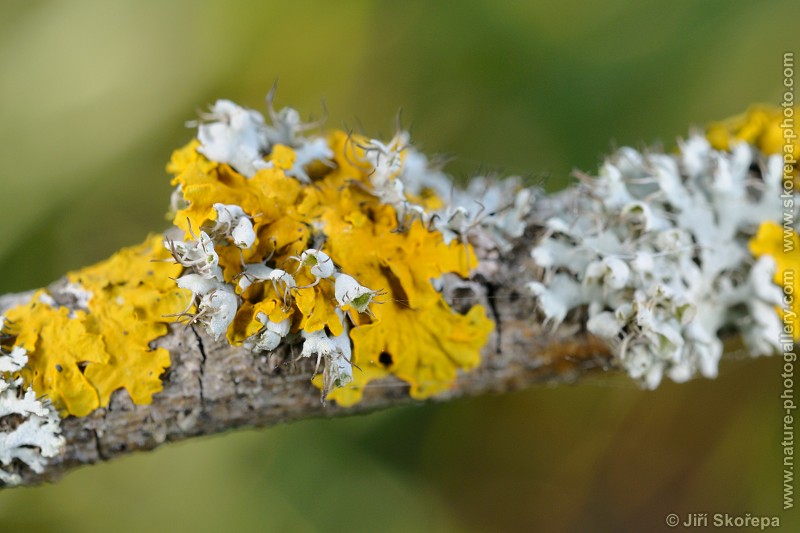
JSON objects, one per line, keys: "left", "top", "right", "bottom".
{"left": 528, "top": 135, "right": 782, "bottom": 388}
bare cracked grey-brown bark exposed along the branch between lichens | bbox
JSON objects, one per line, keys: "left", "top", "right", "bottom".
{"left": 0, "top": 195, "right": 613, "bottom": 485}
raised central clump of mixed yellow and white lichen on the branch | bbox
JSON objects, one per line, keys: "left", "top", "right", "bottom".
{"left": 165, "top": 97, "right": 492, "bottom": 405}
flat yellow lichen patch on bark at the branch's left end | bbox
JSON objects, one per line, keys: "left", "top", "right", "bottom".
{"left": 2, "top": 235, "right": 189, "bottom": 416}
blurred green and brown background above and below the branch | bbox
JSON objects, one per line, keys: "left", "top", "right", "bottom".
{"left": 0, "top": 0, "right": 800, "bottom": 532}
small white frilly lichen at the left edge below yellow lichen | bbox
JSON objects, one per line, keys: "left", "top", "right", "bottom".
{"left": 0, "top": 326, "right": 64, "bottom": 485}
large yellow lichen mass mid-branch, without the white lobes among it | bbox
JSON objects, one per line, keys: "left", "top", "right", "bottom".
{"left": 168, "top": 132, "right": 493, "bottom": 405}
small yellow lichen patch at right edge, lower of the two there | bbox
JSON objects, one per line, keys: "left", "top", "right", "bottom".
{"left": 749, "top": 222, "right": 800, "bottom": 340}
